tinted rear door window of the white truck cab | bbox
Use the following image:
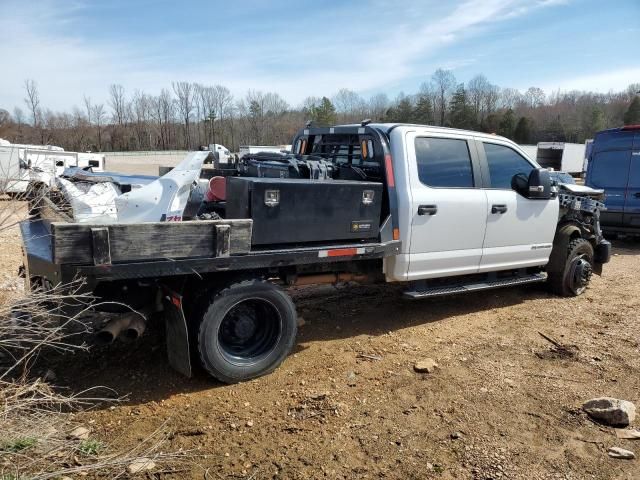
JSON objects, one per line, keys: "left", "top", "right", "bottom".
{"left": 415, "top": 137, "right": 473, "bottom": 188}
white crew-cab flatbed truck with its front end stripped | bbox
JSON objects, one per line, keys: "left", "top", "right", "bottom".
{"left": 21, "top": 121, "right": 611, "bottom": 383}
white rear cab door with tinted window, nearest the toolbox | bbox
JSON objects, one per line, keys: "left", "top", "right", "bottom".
{"left": 406, "top": 131, "right": 487, "bottom": 280}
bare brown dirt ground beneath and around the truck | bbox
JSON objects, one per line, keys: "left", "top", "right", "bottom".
{"left": 0, "top": 200, "right": 640, "bottom": 479}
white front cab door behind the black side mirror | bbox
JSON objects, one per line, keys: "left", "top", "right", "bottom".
{"left": 478, "top": 139, "right": 560, "bottom": 272}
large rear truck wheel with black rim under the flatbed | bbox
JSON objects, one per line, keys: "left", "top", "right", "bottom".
{"left": 197, "top": 280, "right": 298, "bottom": 383}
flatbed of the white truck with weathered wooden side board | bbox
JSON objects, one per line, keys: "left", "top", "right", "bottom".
{"left": 20, "top": 219, "right": 400, "bottom": 289}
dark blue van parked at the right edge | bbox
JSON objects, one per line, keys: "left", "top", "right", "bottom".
{"left": 585, "top": 125, "right": 640, "bottom": 234}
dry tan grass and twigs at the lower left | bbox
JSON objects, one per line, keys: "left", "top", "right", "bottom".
{"left": 0, "top": 190, "right": 199, "bottom": 480}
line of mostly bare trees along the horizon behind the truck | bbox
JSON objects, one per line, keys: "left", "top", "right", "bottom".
{"left": 0, "top": 69, "right": 640, "bottom": 151}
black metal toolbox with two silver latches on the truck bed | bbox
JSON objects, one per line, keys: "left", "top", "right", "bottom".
{"left": 226, "top": 177, "right": 382, "bottom": 245}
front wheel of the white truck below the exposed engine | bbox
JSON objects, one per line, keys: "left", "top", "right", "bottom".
{"left": 548, "top": 238, "right": 593, "bottom": 297}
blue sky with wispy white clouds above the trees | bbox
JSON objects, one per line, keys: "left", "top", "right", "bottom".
{"left": 0, "top": 0, "right": 640, "bottom": 111}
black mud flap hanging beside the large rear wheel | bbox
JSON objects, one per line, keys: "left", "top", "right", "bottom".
{"left": 163, "top": 287, "right": 193, "bottom": 378}
